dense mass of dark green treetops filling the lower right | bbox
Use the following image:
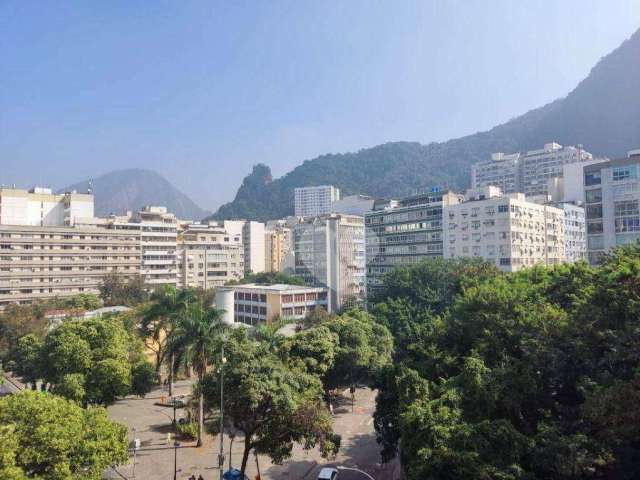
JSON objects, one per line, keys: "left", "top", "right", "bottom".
{"left": 373, "top": 251, "right": 640, "bottom": 480}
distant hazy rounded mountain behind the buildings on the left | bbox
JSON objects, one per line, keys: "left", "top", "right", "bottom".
{"left": 60, "top": 168, "right": 210, "bottom": 220}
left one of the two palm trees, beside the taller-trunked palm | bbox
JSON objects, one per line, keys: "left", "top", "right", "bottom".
{"left": 140, "top": 285, "right": 195, "bottom": 396}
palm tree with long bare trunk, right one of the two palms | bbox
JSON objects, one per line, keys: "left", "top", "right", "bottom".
{"left": 170, "top": 302, "right": 226, "bottom": 447}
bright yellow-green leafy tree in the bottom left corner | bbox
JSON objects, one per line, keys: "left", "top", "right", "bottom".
{"left": 0, "top": 392, "right": 128, "bottom": 480}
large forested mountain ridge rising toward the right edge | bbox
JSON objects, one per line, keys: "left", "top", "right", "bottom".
{"left": 212, "top": 26, "right": 640, "bottom": 221}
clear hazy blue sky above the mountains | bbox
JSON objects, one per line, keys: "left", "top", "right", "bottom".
{"left": 0, "top": 0, "right": 640, "bottom": 209}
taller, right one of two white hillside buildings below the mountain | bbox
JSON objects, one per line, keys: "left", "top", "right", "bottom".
{"left": 519, "top": 142, "right": 593, "bottom": 197}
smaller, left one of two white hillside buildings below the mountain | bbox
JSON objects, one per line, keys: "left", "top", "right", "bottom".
{"left": 471, "top": 152, "right": 520, "bottom": 193}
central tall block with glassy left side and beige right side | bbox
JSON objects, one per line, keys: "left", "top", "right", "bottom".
{"left": 293, "top": 214, "right": 365, "bottom": 311}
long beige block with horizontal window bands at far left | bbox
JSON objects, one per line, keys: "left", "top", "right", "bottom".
{"left": 0, "top": 225, "right": 141, "bottom": 308}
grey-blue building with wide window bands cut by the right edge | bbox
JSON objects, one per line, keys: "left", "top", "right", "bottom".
{"left": 583, "top": 149, "right": 640, "bottom": 263}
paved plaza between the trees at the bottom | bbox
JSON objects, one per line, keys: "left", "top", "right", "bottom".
{"left": 106, "top": 381, "right": 399, "bottom": 480}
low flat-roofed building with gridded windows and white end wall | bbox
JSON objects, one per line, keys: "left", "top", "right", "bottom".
{"left": 215, "top": 284, "right": 330, "bottom": 325}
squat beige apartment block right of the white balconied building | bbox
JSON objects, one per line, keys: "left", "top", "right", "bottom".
{"left": 177, "top": 224, "right": 244, "bottom": 290}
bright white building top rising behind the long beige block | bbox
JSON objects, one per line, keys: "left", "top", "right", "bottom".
{"left": 0, "top": 187, "right": 94, "bottom": 227}
